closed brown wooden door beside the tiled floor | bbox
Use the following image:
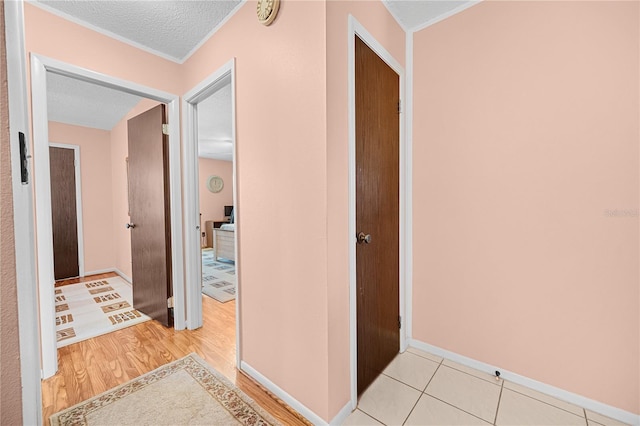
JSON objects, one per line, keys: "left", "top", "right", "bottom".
{"left": 355, "top": 37, "right": 400, "bottom": 395}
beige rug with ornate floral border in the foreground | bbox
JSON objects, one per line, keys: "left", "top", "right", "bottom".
{"left": 51, "top": 353, "right": 280, "bottom": 426}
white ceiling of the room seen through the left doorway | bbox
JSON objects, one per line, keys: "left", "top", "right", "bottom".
{"left": 47, "top": 72, "right": 142, "bottom": 131}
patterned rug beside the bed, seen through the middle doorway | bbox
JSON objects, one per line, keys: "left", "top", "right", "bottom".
{"left": 202, "top": 249, "right": 236, "bottom": 303}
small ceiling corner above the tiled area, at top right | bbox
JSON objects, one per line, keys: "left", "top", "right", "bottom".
{"left": 382, "top": 0, "right": 480, "bottom": 31}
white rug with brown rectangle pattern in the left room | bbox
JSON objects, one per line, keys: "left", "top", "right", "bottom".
{"left": 55, "top": 277, "right": 151, "bottom": 348}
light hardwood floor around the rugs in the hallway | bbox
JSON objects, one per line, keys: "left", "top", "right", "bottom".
{"left": 42, "top": 274, "right": 310, "bottom": 425}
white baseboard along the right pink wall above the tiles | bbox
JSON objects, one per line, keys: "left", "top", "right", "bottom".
{"left": 409, "top": 339, "right": 640, "bottom": 425}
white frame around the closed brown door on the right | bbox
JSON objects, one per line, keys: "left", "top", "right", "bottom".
{"left": 347, "top": 15, "right": 411, "bottom": 409}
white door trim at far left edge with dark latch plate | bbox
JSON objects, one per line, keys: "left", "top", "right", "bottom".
{"left": 4, "top": 1, "right": 42, "bottom": 425}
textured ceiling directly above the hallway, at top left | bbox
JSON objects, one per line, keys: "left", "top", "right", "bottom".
{"left": 34, "top": 0, "right": 244, "bottom": 63}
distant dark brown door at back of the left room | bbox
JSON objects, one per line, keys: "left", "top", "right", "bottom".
{"left": 49, "top": 147, "right": 80, "bottom": 280}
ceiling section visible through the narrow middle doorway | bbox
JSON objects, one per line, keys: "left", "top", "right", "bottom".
{"left": 197, "top": 79, "right": 233, "bottom": 161}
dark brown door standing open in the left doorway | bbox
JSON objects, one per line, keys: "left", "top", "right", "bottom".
{"left": 127, "top": 105, "right": 172, "bottom": 326}
